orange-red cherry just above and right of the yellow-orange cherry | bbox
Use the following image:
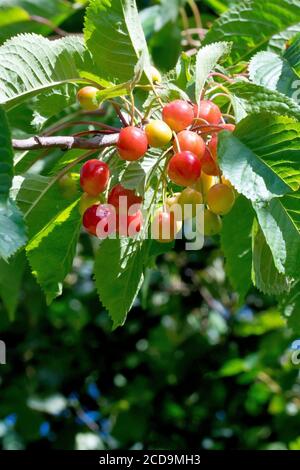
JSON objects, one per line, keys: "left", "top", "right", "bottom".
{"left": 162, "top": 100, "right": 194, "bottom": 132}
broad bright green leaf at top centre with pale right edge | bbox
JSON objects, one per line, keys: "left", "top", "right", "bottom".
{"left": 84, "top": 0, "right": 150, "bottom": 86}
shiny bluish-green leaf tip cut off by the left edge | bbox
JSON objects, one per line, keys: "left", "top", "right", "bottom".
{"left": 0, "top": 200, "right": 27, "bottom": 261}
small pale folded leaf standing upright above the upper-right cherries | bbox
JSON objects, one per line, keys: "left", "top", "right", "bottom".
{"left": 195, "top": 42, "right": 231, "bottom": 102}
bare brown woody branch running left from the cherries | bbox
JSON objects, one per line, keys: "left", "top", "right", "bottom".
{"left": 12, "top": 132, "right": 119, "bottom": 150}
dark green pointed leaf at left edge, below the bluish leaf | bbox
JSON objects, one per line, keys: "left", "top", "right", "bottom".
{"left": 0, "top": 252, "right": 26, "bottom": 320}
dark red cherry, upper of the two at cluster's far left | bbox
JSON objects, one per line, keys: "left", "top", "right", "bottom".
{"left": 80, "top": 159, "right": 110, "bottom": 196}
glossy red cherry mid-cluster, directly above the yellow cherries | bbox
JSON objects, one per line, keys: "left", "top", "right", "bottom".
{"left": 168, "top": 151, "right": 201, "bottom": 186}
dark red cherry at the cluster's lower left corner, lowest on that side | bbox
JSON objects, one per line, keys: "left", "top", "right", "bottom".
{"left": 82, "top": 204, "right": 116, "bottom": 238}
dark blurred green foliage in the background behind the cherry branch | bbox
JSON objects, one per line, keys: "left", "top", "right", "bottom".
{"left": 0, "top": 0, "right": 300, "bottom": 450}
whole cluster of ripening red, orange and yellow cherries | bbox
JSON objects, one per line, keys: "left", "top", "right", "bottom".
{"left": 78, "top": 89, "right": 236, "bottom": 242}
